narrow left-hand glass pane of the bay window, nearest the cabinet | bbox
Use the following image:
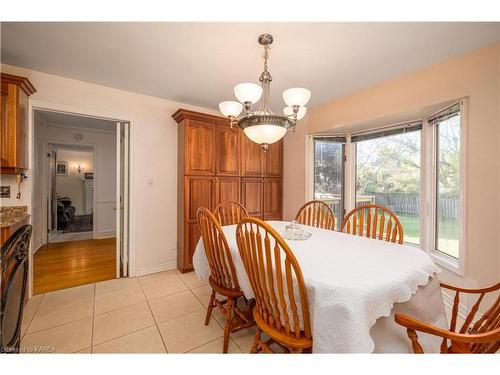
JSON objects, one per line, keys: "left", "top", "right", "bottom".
{"left": 314, "top": 140, "right": 344, "bottom": 229}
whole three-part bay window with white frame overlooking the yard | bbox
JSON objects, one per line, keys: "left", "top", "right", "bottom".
{"left": 312, "top": 100, "right": 465, "bottom": 273}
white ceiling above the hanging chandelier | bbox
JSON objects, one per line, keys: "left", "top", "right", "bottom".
{"left": 1, "top": 22, "right": 500, "bottom": 112}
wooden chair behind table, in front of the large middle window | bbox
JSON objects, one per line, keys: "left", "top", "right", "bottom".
{"left": 341, "top": 204, "right": 404, "bottom": 244}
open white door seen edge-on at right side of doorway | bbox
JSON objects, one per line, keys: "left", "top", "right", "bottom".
{"left": 116, "top": 122, "right": 129, "bottom": 278}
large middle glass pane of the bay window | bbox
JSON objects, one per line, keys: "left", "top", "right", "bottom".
{"left": 356, "top": 130, "right": 421, "bottom": 244}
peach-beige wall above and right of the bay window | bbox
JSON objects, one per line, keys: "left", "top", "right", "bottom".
{"left": 296, "top": 43, "right": 500, "bottom": 286}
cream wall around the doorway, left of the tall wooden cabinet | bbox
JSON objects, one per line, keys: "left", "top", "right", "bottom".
{"left": 1, "top": 65, "right": 215, "bottom": 274}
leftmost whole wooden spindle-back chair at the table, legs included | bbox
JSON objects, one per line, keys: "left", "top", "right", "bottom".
{"left": 197, "top": 207, "right": 255, "bottom": 353}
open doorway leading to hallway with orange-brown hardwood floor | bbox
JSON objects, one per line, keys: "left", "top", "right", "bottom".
{"left": 32, "top": 108, "right": 129, "bottom": 294}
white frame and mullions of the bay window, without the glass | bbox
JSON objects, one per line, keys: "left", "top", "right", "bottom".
{"left": 306, "top": 97, "right": 469, "bottom": 276}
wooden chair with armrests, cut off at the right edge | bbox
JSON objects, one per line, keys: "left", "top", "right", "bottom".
{"left": 394, "top": 282, "right": 500, "bottom": 354}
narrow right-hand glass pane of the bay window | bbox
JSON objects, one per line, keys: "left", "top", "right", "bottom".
{"left": 436, "top": 113, "right": 460, "bottom": 258}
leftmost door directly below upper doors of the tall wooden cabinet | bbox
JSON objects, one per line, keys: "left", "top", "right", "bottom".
{"left": 184, "top": 176, "right": 215, "bottom": 222}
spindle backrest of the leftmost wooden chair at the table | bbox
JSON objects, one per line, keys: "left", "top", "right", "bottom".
{"left": 197, "top": 207, "right": 240, "bottom": 292}
